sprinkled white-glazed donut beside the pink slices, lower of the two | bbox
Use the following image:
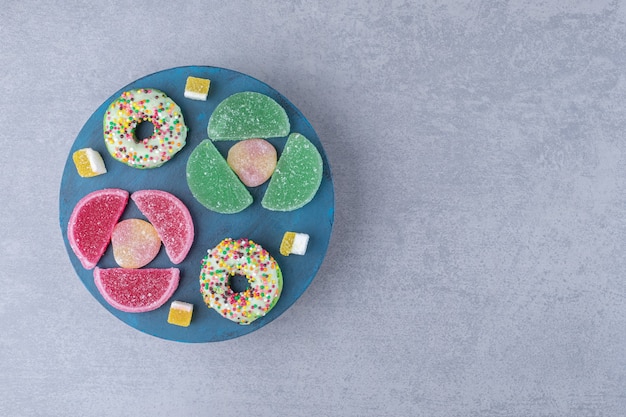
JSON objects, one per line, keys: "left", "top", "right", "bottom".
{"left": 200, "top": 238, "right": 283, "bottom": 324}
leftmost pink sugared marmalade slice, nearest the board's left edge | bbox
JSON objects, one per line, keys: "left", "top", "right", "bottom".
{"left": 67, "top": 188, "right": 128, "bottom": 269}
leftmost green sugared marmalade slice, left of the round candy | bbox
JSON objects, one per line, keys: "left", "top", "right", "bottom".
{"left": 187, "top": 139, "right": 252, "bottom": 214}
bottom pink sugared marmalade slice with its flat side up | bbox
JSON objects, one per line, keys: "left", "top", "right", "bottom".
{"left": 93, "top": 268, "right": 180, "bottom": 313}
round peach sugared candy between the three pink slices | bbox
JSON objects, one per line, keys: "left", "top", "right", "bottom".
{"left": 111, "top": 219, "right": 161, "bottom": 268}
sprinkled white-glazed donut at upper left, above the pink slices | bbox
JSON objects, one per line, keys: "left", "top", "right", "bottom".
{"left": 103, "top": 88, "right": 188, "bottom": 169}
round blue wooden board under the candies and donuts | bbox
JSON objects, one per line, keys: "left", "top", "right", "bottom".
{"left": 59, "top": 66, "right": 334, "bottom": 343}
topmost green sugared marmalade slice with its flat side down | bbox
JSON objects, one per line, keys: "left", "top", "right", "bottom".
{"left": 207, "top": 91, "right": 290, "bottom": 140}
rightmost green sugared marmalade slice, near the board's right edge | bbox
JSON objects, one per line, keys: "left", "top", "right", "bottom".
{"left": 261, "top": 133, "right": 324, "bottom": 211}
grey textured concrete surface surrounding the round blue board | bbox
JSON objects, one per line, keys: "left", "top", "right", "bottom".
{"left": 0, "top": 0, "right": 626, "bottom": 417}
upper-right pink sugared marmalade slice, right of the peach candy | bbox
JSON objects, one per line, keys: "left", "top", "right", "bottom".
{"left": 131, "top": 190, "right": 194, "bottom": 264}
